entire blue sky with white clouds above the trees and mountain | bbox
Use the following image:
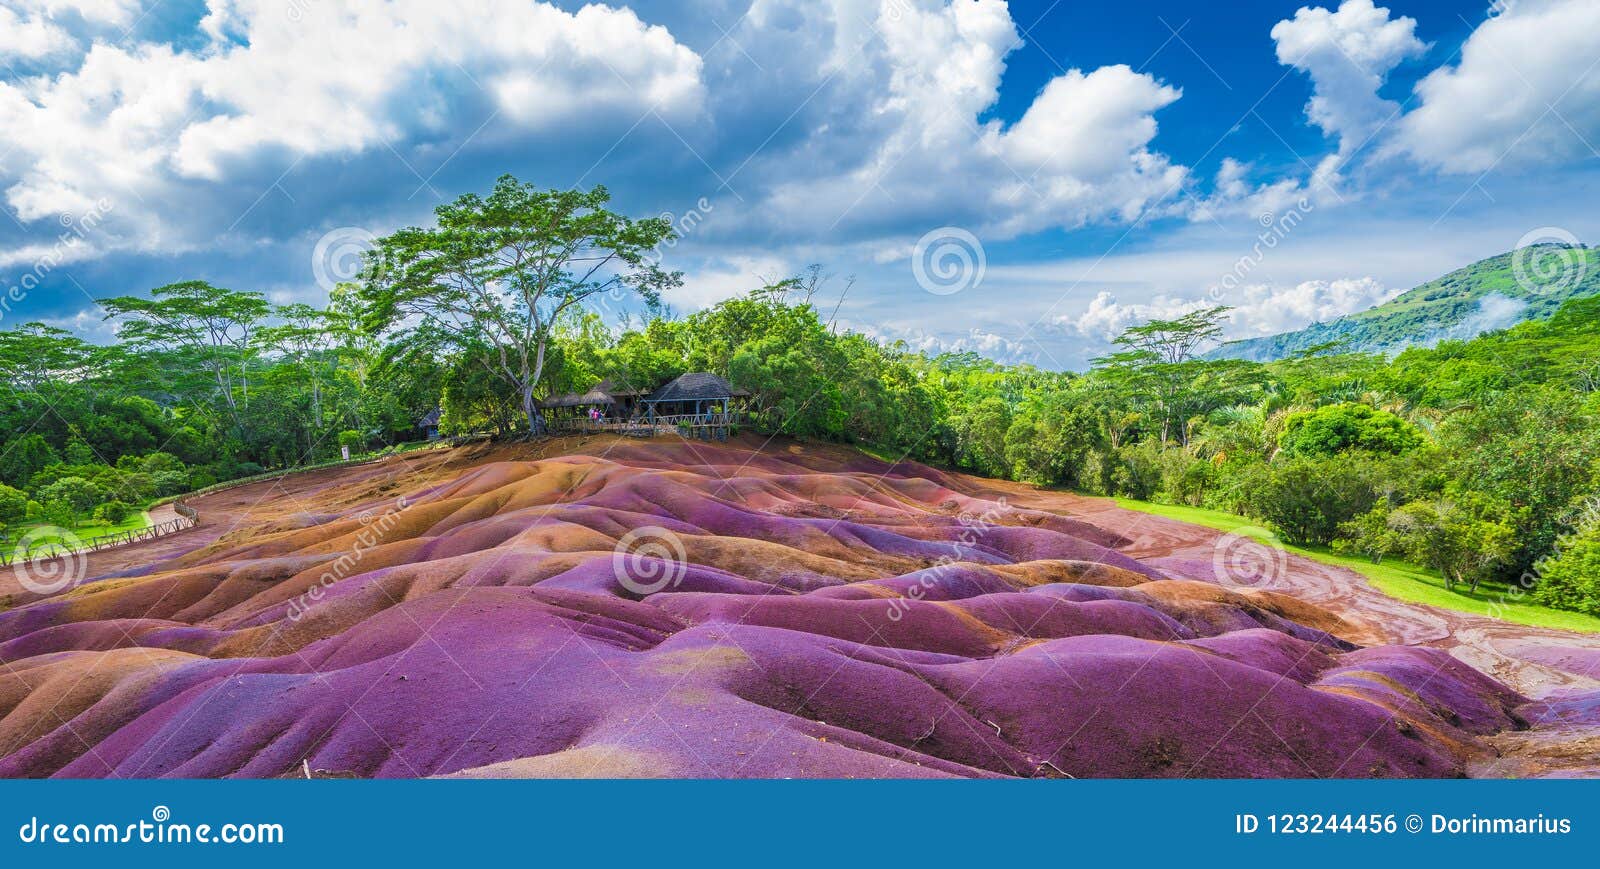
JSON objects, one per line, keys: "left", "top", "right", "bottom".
{"left": 0, "top": 0, "right": 1600, "bottom": 368}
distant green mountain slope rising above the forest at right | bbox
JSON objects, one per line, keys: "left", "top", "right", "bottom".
{"left": 1208, "top": 245, "right": 1600, "bottom": 362}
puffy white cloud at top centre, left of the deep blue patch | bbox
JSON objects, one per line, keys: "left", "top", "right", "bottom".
{"left": 750, "top": 0, "right": 1187, "bottom": 237}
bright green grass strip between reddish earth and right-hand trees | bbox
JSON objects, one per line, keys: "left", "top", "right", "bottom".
{"left": 1117, "top": 498, "right": 1600, "bottom": 632}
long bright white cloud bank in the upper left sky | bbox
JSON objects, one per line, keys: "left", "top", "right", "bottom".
{"left": 0, "top": 0, "right": 704, "bottom": 250}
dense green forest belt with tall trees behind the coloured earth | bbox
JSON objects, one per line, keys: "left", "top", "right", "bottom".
{"left": 0, "top": 178, "right": 1600, "bottom": 615}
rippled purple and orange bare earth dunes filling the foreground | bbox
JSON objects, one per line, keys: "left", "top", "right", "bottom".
{"left": 0, "top": 439, "right": 1594, "bottom": 776}
